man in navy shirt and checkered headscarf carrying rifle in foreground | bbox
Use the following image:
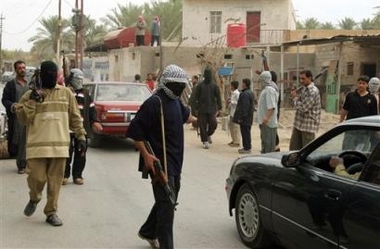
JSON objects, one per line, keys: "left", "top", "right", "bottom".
{"left": 127, "top": 65, "right": 195, "bottom": 249}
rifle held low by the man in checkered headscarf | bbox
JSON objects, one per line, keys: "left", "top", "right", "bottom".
{"left": 142, "top": 141, "right": 177, "bottom": 205}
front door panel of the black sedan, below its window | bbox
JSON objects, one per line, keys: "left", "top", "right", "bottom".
{"left": 272, "top": 166, "right": 350, "bottom": 249}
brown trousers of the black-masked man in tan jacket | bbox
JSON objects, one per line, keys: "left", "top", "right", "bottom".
{"left": 26, "top": 158, "right": 66, "bottom": 216}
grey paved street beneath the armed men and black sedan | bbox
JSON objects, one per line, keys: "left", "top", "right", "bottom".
{"left": 0, "top": 125, "right": 255, "bottom": 249}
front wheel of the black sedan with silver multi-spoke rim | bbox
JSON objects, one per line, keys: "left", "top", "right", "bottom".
{"left": 235, "top": 184, "right": 270, "bottom": 248}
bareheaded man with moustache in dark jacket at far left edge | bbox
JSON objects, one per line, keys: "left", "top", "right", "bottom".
{"left": 1, "top": 60, "right": 29, "bottom": 174}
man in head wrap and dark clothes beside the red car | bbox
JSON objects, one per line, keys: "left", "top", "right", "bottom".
{"left": 62, "top": 68, "right": 103, "bottom": 185}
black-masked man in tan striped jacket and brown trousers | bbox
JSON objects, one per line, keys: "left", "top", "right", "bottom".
{"left": 16, "top": 61, "right": 86, "bottom": 226}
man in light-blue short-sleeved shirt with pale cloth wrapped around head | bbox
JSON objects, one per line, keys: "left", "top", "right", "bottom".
{"left": 257, "top": 71, "right": 279, "bottom": 154}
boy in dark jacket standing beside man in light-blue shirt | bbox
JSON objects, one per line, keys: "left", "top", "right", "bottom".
{"left": 233, "top": 78, "right": 255, "bottom": 154}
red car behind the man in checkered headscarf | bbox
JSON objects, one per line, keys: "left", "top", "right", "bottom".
{"left": 84, "top": 82, "right": 152, "bottom": 147}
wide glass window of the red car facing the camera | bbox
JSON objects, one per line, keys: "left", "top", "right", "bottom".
{"left": 95, "top": 84, "right": 151, "bottom": 102}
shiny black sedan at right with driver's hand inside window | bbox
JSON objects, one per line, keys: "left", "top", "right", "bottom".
{"left": 226, "top": 116, "right": 380, "bottom": 249}
